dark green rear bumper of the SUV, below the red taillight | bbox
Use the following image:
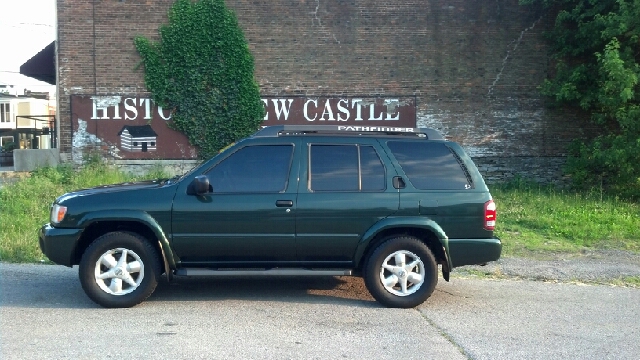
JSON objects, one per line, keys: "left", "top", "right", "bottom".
{"left": 449, "top": 238, "right": 502, "bottom": 268}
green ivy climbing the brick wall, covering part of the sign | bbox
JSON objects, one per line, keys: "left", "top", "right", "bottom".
{"left": 134, "top": 0, "right": 264, "bottom": 158}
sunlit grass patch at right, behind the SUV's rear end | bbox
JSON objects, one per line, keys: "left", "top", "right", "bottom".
{"left": 491, "top": 181, "right": 640, "bottom": 257}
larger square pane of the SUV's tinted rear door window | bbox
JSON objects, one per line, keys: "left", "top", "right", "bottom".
{"left": 310, "top": 145, "right": 359, "bottom": 191}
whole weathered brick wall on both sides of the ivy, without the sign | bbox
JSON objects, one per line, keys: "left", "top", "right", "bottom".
{"left": 58, "top": 0, "right": 586, "bottom": 183}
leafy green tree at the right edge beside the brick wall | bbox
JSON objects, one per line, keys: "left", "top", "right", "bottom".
{"left": 520, "top": 0, "right": 640, "bottom": 199}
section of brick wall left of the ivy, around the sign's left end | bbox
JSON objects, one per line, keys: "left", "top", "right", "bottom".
{"left": 57, "top": 0, "right": 173, "bottom": 159}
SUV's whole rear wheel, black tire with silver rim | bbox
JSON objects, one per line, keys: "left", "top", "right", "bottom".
{"left": 364, "top": 236, "right": 438, "bottom": 308}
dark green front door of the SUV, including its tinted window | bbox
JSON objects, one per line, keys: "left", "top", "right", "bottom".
{"left": 172, "top": 144, "right": 298, "bottom": 267}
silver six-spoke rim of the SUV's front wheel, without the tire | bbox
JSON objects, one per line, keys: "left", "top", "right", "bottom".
{"left": 94, "top": 248, "right": 144, "bottom": 296}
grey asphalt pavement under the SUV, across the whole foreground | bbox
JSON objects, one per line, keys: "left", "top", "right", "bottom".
{"left": 0, "top": 263, "right": 640, "bottom": 360}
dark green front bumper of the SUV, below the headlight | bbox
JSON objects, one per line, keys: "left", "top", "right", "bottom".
{"left": 39, "top": 224, "right": 82, "bottom": 267}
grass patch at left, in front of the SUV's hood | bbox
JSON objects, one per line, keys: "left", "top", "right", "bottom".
{"left": 0, "top": 161, "right": 166, "bottom": 263}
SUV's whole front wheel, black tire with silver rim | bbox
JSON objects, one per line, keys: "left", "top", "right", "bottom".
{"left": 78, "top": 232, "right": 162, "bottom": 308}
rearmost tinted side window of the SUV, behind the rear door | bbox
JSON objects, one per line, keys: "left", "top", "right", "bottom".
{"left": 387, "top": 141, "right": 471, "bottom": 190}
